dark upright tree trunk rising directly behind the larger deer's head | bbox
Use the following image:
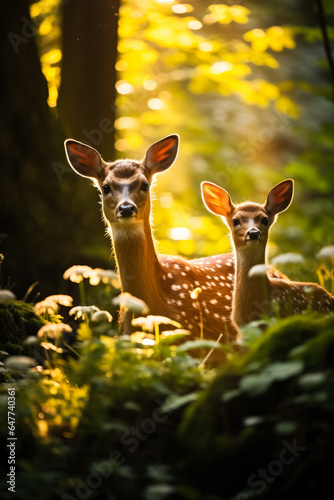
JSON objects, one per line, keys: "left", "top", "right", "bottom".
{"left": 58, "top": 0, "right": 119, "bottom": 159}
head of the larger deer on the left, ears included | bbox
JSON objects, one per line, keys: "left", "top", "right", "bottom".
{"left": 65, "top": 134, "right": 179, "bottom": 226}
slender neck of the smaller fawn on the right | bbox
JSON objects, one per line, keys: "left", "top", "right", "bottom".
{"left": 232, "top": 247, "right": 270, "bottom": 326}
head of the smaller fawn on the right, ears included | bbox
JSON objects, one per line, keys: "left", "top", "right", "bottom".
{"left": 201, "top": 179, "right": 293, "bottom": 251}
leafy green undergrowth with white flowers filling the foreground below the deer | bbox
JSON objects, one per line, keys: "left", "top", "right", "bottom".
{"left": 0, "top": 309, "right": 334, "bottom": 500}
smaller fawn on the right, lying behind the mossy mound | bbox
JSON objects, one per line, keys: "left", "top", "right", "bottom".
{"left": 202, "top": 179, "right": 334, "bottom": 327}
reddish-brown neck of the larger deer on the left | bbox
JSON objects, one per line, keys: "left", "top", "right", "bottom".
{"left": 111, "top": 220, "right": 163, "bottom": 309}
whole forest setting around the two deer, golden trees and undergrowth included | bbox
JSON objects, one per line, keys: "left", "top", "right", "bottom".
{"left": 0, "top": 0, "right": 334, "bottom": 500}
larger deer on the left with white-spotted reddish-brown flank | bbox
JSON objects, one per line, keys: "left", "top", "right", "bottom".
{"left": 65, "top": 135, "right": 237, "bottom": 340}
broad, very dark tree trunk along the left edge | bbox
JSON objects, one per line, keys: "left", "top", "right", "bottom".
{"left": 0, "top": 0, "right": 108, "bottom": 297}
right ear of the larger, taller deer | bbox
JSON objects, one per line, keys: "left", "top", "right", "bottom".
{"left": 143, "top": 134, "right": 179, "bottom": 175}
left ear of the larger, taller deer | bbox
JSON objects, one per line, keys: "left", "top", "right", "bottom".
{"left": 65, "top": 139, "right": 104, "bottom": 179}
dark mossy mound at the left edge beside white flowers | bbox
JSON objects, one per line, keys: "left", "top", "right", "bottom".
{"left": 0, "top": 301, "right": 44, "bottom": 354}
